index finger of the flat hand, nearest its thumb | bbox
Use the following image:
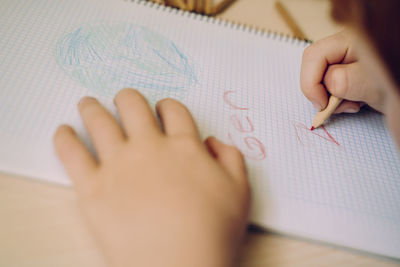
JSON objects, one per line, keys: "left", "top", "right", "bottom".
{"left": 156, "top": 99, "right": 200, "bottom": 138}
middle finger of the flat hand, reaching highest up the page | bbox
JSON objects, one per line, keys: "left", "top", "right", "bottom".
{"left": 114, "top": 89, "right": 161, "bottom": 137}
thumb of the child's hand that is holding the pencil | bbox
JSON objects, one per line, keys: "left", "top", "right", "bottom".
{"left": 324, "top": 62, "right": 382, "bottom": 110}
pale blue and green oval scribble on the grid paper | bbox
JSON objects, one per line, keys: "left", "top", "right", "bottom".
{"left": 56, "top": 24, "right": 197, "bottom": 95}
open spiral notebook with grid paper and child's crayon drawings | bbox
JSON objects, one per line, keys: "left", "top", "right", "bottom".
{"left": 0, "top": 0, "right": 400, "bottom": 258}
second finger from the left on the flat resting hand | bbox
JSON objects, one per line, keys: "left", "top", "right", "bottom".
{"left": 78, "top": 97, "right": 125, "bottom": 160}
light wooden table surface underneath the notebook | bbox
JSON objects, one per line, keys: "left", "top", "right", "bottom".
{"left": 0, "top": 0, "right": 400, "bottom": 267}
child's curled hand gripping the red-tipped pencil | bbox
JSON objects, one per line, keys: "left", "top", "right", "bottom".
{"left": 300, "top": 31, "right": 383, "bottom": 113}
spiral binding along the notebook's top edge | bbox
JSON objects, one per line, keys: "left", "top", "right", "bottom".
{"left": 124, "top": 0, "right": 312, "bottom": 46}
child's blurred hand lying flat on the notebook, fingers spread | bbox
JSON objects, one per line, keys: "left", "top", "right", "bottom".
{"left": 54, "top": 89, "right": 249, "bottom": 267}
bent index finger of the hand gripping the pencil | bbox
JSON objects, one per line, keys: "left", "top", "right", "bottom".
{"left": 300, "top": 32, "right": 356, "bottom": 110}
